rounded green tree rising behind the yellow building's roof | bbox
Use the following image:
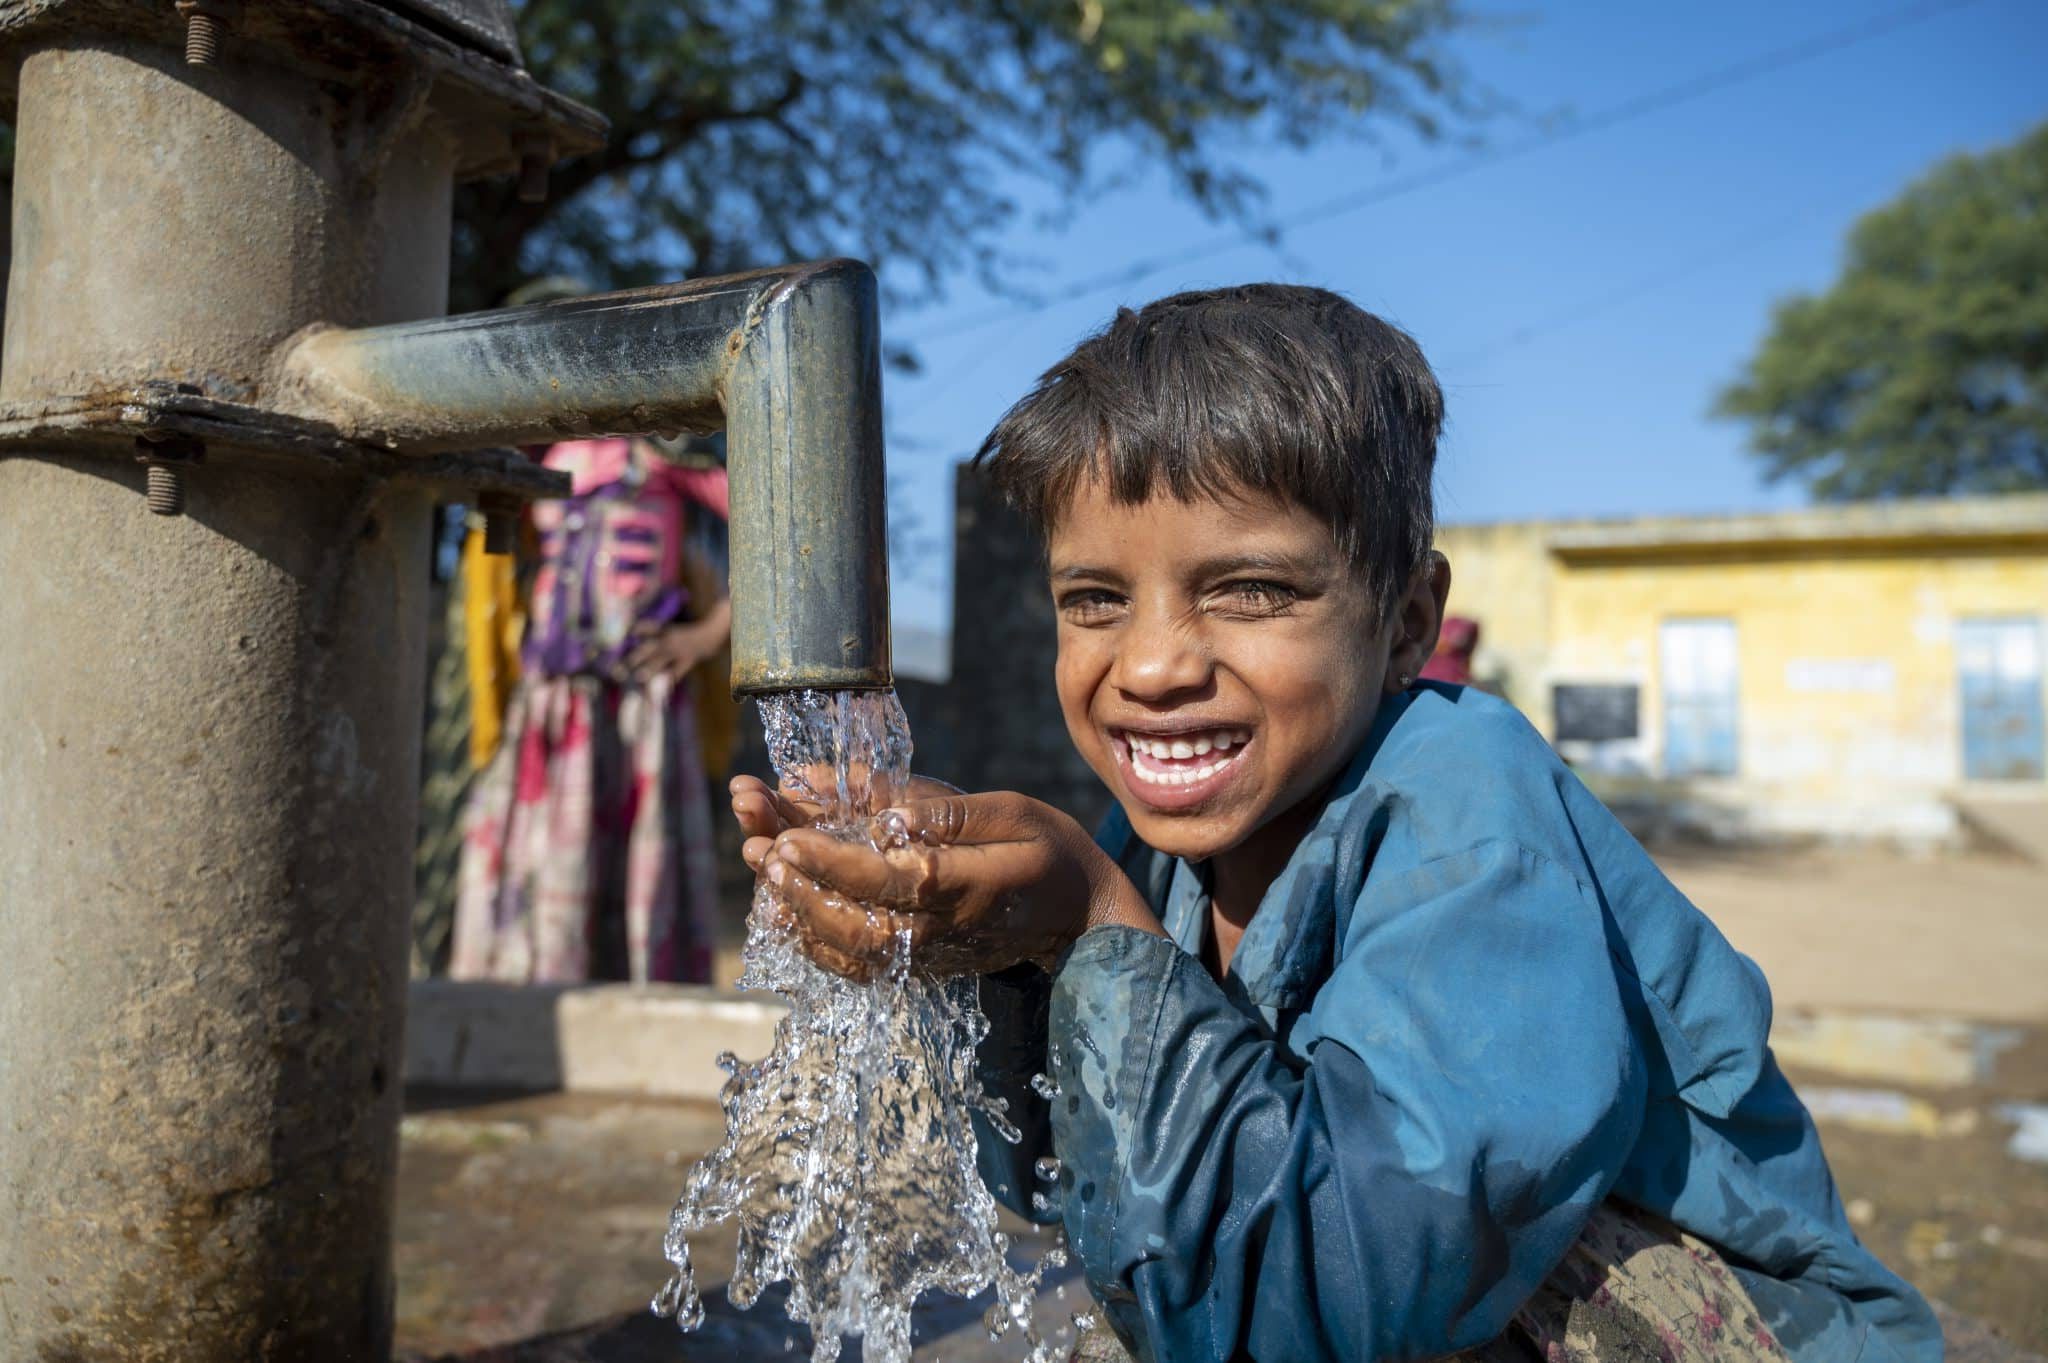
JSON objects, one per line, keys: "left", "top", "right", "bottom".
{"left": 1716, "top": 125, "right": 2048, "bottom": 499}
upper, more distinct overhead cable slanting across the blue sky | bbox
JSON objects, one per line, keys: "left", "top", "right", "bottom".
{"left": 918, "top": 0, "right": 1978, "bottom": 342}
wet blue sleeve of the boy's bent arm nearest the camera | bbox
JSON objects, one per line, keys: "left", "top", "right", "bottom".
{"left": 1049, "top": 843, "right": 1645, "bottom": 1363}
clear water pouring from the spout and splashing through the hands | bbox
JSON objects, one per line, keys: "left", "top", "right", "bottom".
{"left": 653, "top": 692, "right": 1065, "bottom": 1363}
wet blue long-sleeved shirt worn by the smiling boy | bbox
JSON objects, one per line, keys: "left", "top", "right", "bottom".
{"left": 977, "top": 684, "right": 1942, "bottom": 1363}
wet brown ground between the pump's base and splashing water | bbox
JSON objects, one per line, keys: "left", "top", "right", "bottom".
{"left": 397, "top": 1093, "right": 1085, "bottom": 1363}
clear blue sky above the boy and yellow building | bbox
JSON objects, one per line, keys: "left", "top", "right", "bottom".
{"left": 883, "top": 0, "right": 2048, "bottom": 628}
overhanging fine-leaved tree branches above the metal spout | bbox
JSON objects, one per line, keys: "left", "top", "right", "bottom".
{"left": 455, "top": 0, "right": 1473, "bottom": 309}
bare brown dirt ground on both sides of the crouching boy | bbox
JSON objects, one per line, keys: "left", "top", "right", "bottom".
{"left": 397, "top": 847, "right": 2048, "bottom": 1363}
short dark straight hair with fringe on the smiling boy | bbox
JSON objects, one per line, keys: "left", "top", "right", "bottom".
{"left": 975, "top": 284, "right": 1444, "bottom": 614}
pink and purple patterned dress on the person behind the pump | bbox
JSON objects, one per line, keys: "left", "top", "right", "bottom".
{"left": 449, "top": 440, "right": 727, "bottom": 984}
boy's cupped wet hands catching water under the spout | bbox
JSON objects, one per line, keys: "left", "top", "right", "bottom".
{"left": 762, "top": 792, "right": 1161, "bottom": 978}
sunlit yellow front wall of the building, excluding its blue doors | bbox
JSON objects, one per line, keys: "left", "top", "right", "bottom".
{"left": 1546, "top": 548, "right": 2048, "bottom": 837}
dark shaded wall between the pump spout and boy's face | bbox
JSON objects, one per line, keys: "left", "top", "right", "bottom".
{"left": 897, "top": 465, "right": 1110, "bottom": 829}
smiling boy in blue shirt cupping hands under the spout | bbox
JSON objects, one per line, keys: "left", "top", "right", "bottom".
{"left": 733, "top": 284, "right": 1942, "bottom": 1363}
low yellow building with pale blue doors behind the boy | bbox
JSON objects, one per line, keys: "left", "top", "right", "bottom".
{"left": 1438, "top": 495, "right": 2048, "bottom": 839}
